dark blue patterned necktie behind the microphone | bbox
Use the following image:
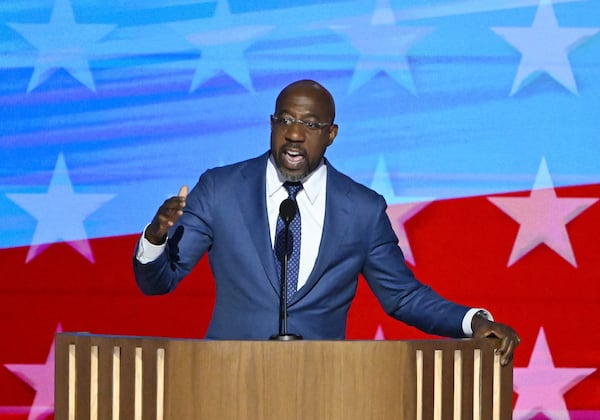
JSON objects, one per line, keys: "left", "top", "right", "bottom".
{"left": 275, "top": 182, "right": 302, "bottom": 302}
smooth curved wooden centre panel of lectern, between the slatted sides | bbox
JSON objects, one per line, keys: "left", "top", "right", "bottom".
{"left": 166, "top": 341, "right": 414, "bottom": 419}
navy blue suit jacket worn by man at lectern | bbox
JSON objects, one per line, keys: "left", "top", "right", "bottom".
{"left": 133, "top": 153, "right": 469, "bottom": 339}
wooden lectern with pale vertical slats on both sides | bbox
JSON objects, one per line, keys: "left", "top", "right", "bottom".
{"left": 55, "top": 333, "right": 513, "bottom": 420}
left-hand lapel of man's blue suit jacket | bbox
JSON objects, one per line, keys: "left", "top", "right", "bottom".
{"left": 237, "top": 153, "right": 280, "bottom": 294}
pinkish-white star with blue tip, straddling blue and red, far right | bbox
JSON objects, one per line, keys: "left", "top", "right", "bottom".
{"left": 488, "top": 158, "right": 598, "bottom": 267}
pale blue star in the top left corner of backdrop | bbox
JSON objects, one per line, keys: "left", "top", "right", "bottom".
{"left": 8, "top": 0, "right": 116, "bottom": 92}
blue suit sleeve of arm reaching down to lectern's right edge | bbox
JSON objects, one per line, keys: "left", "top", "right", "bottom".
{"left": 362, "top": 196, "right": 470, "bottom": 337}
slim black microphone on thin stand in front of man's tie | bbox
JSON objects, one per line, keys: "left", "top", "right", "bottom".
{"left": 270, "top": 198, "right": 302, "bottom": 341}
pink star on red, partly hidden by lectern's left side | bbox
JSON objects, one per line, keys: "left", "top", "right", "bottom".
{"left": 4, "top": 324, "right": 62, "bottom": 420}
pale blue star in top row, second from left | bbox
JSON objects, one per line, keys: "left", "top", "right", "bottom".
{"left": 172, "top": 0, "right": 274, "bottom": 93}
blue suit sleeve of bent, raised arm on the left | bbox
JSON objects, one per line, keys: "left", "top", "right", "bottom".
{"left": 133, "top": 172, "right": 212, "bottom": 295}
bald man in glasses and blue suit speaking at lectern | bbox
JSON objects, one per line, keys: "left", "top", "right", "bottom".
{"left": 133, "top": 80, "right": 520, "bottom": 364}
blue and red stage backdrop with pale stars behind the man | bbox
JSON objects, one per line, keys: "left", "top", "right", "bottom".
{"left": 0, "top": 0, "right": 600, "bottom": 419}
